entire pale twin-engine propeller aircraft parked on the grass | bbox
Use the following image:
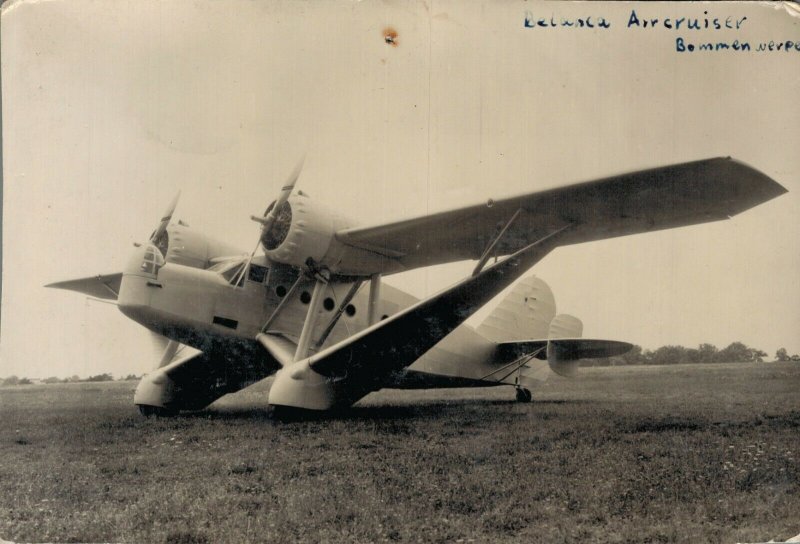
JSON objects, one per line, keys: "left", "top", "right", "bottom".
{"left": 49, "top": 158, "right": 786, "bottom": 415}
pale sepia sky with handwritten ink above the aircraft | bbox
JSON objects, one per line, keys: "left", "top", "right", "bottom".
{"left": 0, "top": 0, "right": 800, "bottom": 378}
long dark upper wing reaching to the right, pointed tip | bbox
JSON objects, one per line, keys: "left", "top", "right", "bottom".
{"left": 336, "top": 157, "right": 786, "bottom": 270}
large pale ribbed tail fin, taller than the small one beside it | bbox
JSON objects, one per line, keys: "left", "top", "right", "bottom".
{"left": 476, "top": 276, "right": 556, "bottom": 342}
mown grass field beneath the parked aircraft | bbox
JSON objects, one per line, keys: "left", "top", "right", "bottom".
{"left": 0, "top": 363, "right": 800, "bottom": 543}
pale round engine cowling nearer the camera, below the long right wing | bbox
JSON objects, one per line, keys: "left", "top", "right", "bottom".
{"left": 261, "top": 193, "right": 352, "bottom": 272}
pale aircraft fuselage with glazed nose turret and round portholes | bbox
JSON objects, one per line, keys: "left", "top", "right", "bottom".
{"left": 117, "top": 227, "right": 502, "bottom": 410}
